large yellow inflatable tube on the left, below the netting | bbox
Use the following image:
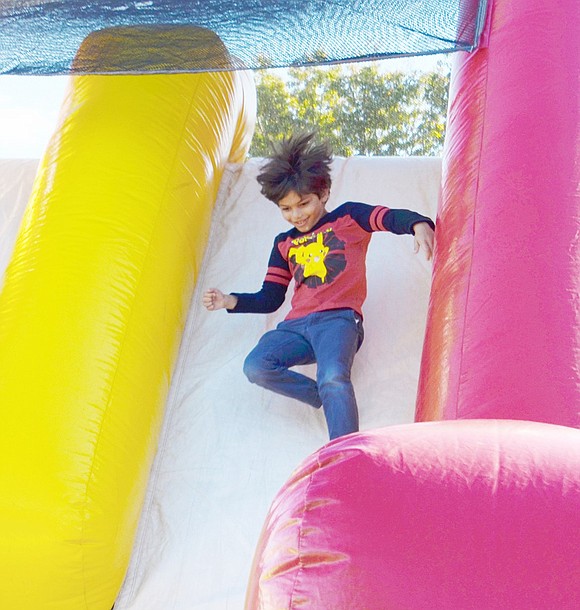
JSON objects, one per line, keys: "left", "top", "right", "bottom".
{"left": 0, "top": 27, "right": 255, "bottom": 610}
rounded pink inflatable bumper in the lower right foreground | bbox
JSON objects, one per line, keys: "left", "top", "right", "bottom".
{"left": 246, "top": 420, "right": 580, "bottom": 610}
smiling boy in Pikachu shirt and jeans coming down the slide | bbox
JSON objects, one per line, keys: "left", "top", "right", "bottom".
{"left": 203, "top": 133, "right": 435, "bottom": 440}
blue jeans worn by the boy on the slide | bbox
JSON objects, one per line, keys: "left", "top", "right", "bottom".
{"left": 244, "top": 309, "right": 364, "bottom": 439}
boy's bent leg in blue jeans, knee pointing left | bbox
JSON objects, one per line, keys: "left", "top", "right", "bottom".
{"left": 244, "top": 321, "right": 322, "bottom": 408}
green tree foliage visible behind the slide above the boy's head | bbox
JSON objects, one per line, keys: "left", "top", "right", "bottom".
{"left": 249, "top": 64, "right": 449, "bottom": 157}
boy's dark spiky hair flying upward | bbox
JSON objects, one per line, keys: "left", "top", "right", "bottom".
{"left": 257, "top": 132, "right": 332, "bottom": 204}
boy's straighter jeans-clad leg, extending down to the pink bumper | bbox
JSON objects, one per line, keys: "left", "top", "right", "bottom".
{"left": 306, "top": 310, "right": 364, "bottom": 440}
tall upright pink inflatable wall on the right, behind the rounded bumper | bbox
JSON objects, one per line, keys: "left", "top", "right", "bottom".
{"left": 416, "top": 0, "right": 580, "bottom": 427}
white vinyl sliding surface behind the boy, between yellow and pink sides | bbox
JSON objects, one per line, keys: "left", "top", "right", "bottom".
{"left": 0, "top": 148, "right": 441, "bottom": 610}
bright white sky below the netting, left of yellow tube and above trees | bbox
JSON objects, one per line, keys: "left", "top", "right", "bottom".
{"left": 0, "top": 55, "right": 446, "bottom": 159}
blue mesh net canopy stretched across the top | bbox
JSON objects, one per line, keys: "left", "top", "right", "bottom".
{"left": 0, "top": 0, "right": 486, "bottom": 75}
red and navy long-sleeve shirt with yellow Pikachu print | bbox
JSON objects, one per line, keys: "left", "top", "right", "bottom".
{"left": 229, "top": 202, "right": 435, "bottom": 320}
